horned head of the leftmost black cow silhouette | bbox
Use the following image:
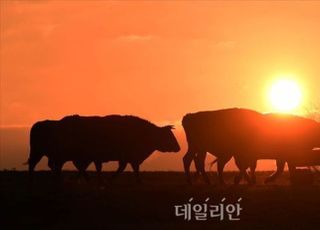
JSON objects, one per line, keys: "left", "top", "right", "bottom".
{"left": 157, "top": 125, "right": 180, "bottom": 152}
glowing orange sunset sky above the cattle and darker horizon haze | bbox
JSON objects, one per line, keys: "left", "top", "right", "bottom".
{"left": 0, "top": 0, "right": 320, "bottom": 171}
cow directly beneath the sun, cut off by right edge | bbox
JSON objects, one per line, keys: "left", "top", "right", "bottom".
{"left": 234, "top": 114, "right": 320, "bottom": 183}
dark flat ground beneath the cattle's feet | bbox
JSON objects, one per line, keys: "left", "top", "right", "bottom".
{"left": 0, "top": 171, "right": 320, "bottom": 230}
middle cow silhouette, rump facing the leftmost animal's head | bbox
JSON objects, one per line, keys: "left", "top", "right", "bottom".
{"left": 182, "top": 108, "right": 263, "bottom": 184}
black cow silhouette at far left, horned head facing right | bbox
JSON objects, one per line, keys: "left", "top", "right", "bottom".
{"left": 28, "top": 115, "right": 180, "bottom": 182}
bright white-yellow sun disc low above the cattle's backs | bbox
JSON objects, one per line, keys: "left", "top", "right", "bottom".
{"left": 269, "top": 79, "right": 302, "bottom": 113}
